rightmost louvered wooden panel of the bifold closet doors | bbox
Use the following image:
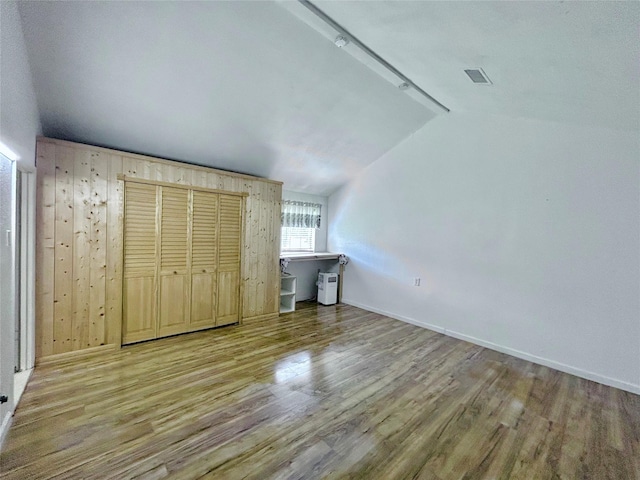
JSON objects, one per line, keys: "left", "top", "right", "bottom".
{"left": 217, "top": 195, "right": 242, "bottom": 325}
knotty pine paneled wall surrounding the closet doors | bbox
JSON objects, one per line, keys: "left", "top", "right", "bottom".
{"left": 36, "top": 138, "right": 282, "bottom": 360}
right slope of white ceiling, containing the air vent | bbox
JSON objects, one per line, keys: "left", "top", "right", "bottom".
{"left": 314, "top": 0, "right": 640, "bottom": 131}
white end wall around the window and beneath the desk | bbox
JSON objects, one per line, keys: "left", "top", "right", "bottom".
{"left": 282, "top": 190, "right": 335, "bottom": 302}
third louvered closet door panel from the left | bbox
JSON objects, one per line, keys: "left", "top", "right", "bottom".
{"left": 189, "top": 190, "right": 218, "bottom": 330}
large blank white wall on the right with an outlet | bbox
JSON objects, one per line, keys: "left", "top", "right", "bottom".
{"left": 329, "top": 113, "right": 640, "bottom": 392}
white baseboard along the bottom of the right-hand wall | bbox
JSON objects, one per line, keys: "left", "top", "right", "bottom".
{"left": 342, "top": 299, "right": 640, "bottom": 395}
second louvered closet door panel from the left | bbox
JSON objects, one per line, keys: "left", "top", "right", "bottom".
{"left": 158, "top": 187, "right": 191, "bottom": 337}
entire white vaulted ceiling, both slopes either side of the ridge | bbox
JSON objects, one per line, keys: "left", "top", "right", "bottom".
{"left": 20, "top": 1, "right": 640, "bottom": 195}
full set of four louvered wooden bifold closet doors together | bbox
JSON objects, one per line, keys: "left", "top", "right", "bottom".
{"left": 122, "top": 182, "right": 244, "bottom": 344}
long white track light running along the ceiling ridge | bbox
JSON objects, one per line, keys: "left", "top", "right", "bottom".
{"left": 281, "top": 0, "right": 449, "bottom": 113}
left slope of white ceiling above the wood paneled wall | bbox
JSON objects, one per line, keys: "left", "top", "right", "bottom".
{"left": 20, "top": 2, "right": 434, "bottom": 195}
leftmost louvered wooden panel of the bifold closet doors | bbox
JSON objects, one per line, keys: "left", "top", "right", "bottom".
{"left": 122, "top": 182, "right": 158, "bottom": 344}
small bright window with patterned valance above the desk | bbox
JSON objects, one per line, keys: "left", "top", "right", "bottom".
{"left": 280, "top": 200, "right": 322, "bottom": 252}
